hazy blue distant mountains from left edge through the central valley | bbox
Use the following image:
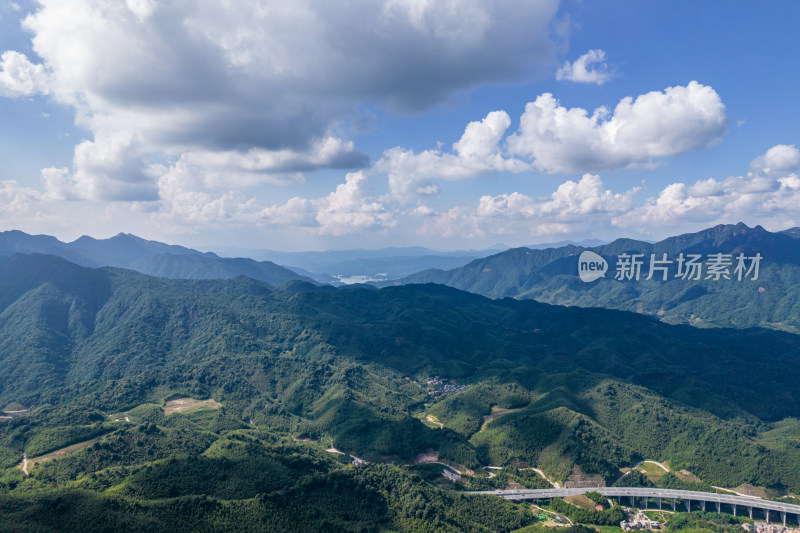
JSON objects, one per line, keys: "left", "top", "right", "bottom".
{"left": 0, "top": 230, "right": 602, "bottom": 285}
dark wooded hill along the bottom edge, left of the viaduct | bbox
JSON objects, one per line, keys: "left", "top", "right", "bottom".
{"left": 0, "top": 430, "right": 532, "bottom": 532}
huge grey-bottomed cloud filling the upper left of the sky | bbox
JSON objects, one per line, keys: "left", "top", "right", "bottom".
{"left": 0, "top": 0, "right": 558, "bottom": 201}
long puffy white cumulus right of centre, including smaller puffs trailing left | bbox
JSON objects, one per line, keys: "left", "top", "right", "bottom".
{"left": 374, "top": 81, "right": 732, "bottom": 193}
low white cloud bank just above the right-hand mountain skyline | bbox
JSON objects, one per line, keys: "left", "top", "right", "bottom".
{"left": 420, "top": 145, "right": 800, "bottom": 242}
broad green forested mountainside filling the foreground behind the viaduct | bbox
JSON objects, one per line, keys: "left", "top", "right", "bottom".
{"left": 0, "top": 254, "right": 800, "bottom": 531}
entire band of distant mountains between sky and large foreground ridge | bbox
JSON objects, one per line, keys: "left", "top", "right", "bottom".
{"left": 6, "top": 223, "right": 800, "bottom": 333}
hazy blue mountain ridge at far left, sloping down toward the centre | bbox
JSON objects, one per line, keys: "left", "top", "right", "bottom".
{"left": 0, "top": 231, "right": 312, "bottom": 285}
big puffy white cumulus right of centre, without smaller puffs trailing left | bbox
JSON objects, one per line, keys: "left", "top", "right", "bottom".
{"left": 508, "top": 81, "right": 729, "bottom": 173}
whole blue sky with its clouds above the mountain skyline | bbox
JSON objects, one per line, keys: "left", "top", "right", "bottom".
{"left": 0, "top": 0, "right": 800, "bottom": 250}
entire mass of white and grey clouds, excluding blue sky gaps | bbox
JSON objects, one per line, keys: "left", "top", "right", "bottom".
{"left": 0, "top": 0, "right": 800, "bottom": 245}
